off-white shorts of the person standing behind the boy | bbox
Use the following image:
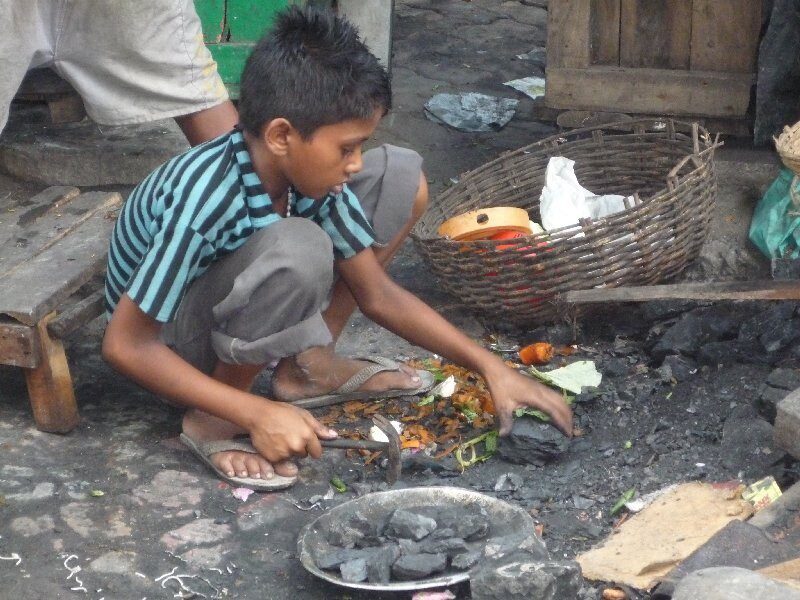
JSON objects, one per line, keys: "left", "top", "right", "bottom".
{"left": 0, "top": 0, "right": 228, "bottom": 130}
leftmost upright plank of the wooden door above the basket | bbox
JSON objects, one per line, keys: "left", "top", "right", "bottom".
{"left": 547, "top": 0, "right": 591, "bottom": 70}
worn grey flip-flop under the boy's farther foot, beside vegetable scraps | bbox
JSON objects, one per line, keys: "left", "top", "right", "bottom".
{"left": 291, "top": 356, "right": 436, "bottom": 409}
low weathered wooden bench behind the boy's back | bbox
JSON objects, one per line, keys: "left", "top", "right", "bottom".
{"left": 0, "top": 187, "right": 122, "bottom": 433}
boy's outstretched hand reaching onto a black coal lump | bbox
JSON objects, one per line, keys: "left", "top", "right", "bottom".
{"left": 486, "top": 365, "right": 572, "bottom": 437}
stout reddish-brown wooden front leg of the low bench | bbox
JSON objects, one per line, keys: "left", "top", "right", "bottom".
{"left": 25, "top": 314, "right": 79, "bottom": 433}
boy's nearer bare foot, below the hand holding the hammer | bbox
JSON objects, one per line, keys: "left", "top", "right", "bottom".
{"left": 183, "top": 409, "right": 297, "bottom": 479}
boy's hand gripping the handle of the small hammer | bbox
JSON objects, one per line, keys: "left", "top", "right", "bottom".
{"left": 250, "top": 401, "right": 337, "bottom": 464}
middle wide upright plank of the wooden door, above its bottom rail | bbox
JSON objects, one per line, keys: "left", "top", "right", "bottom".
{"left": 619, "top": 0, "right": 692, "bottom": 69}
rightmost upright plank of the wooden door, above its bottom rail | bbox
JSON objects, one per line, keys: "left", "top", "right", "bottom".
{"left": 691, "top": 0, "right": 761, "bottom": 73}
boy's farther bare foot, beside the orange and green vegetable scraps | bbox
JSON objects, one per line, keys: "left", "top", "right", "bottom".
{"left": 272, "top": 346, "right": 422, "bottom": 401}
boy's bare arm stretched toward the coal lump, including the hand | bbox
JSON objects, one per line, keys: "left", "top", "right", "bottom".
{"left": 337, "top": 249, "right": 572, "bottom": 436}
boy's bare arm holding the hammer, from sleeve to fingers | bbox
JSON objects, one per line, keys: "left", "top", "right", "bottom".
{"left": 103, "top": 295, "right": 335, "bottom": 463}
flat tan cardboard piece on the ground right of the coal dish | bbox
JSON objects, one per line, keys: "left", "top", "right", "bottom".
{"left": 577, "top": 482, "right": 753, "bottom": 590}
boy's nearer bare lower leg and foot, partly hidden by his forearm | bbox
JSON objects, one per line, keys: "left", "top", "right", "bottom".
{"left": 183, "top": 362, "right": 297, "bottom": 479}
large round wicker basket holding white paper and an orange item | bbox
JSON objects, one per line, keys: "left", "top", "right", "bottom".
{"left": 412, "top": 119, "right": 717, "bottom": 328}
